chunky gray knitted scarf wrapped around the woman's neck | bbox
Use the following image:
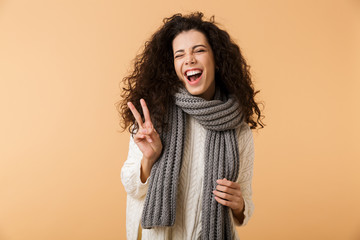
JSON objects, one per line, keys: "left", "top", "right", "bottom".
{"left": 141, "top": 89, "right": 243, "bottom": 239}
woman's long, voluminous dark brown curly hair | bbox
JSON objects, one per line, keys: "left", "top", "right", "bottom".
{"left": 117, "top": 12, "right": 264, "bottom": 133}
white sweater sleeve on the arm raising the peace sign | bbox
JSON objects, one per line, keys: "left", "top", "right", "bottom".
{"left": 121, "top": 136, "right": 150, "bottom": 199}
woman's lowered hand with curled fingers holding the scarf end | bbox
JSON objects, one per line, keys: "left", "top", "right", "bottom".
{"left": 213, "top": 178, "right": 245, "bottom": 223}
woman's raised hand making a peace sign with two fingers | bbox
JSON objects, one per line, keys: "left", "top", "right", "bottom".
{"left": 128, "top": 99, "right": 162, "bottom": 165}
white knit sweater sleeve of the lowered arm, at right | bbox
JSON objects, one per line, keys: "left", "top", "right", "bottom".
{"left": 234, "top": 124, "right": 254, "bottom": 226}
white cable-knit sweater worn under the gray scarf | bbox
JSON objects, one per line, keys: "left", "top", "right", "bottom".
{"left": 121, "top": 116, "right": 254, "bottom": 240}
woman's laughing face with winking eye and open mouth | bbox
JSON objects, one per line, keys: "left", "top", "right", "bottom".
{"left": 172, "top": 30, "right": 215, "bottom": 100}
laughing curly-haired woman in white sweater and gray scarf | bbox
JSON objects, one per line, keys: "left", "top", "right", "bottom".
{"left": 118, "top": 13, "right": 263, "bottom": 239}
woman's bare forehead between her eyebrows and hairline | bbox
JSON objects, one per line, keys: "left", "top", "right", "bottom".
{"left": 172, "top": 30, "right": 209, "bottom": 51}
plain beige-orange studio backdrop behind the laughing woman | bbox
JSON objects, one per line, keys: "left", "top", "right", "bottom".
{"left": 0, "top": 0, "right": 360, "bottom": 240}
